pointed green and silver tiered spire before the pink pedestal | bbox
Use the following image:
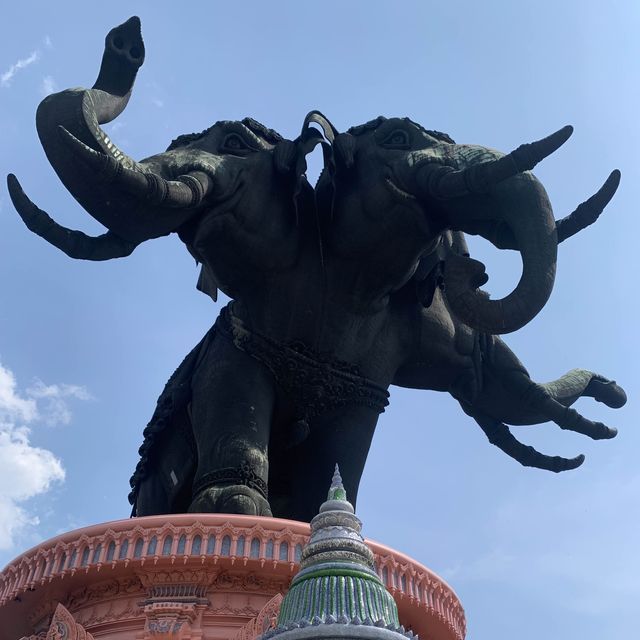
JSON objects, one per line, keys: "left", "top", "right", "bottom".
{"left": 278, "top": 465, "right": 400, "bottom": 630}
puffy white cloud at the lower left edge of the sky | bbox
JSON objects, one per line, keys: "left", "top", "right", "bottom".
{"left": 0, "top": 365, "right": 90, "bottom": 549}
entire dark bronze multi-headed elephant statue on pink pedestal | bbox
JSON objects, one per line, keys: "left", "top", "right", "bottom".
{"left": 8, "top": 18, "right": 624, "bottom": 520}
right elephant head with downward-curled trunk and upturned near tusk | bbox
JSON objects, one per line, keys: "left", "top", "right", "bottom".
{"left": 324, "top": 117, "right": 572, "bottom": 334}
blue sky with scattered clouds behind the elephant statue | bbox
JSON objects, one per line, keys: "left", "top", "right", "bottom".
{"left": 0, "top": 0, "right": 640, "bottom": 640}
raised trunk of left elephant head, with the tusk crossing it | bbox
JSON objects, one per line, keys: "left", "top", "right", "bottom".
{"left": 29, "top": 16, "right": 220, "bottom": 246}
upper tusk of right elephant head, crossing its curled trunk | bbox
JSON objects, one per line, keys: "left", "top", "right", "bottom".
{"left": 418, "top": 125, "right": 573, "bottom": 200}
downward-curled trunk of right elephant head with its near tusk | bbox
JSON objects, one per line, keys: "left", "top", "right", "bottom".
{"left": 410, "top": 127, "right": 572, "bottom": 334}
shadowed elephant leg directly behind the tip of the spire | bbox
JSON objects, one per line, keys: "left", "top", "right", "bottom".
{"left": 274, "top": 406, "right": 379, "bottom": 522}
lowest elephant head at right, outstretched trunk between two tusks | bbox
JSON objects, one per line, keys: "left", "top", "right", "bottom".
{"left": 393, "top": 230, "right": 626, "bottom": 473}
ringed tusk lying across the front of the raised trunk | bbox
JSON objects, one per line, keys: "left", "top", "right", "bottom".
{"left": 58, "top": 125, "right": 214, "bottom": 209}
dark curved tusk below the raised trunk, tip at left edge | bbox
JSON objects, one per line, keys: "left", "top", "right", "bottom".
{"left": 7, "top": 173, "right": 138, "bottom": 261}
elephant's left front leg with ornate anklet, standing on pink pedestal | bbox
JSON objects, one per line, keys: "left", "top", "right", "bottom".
{"left": 189, "top": 335, "right": 275, "bottom": 515}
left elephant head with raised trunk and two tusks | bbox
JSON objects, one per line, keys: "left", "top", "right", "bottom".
{"left": 8, "top": 17, "right": 297, "bottom": 286}
